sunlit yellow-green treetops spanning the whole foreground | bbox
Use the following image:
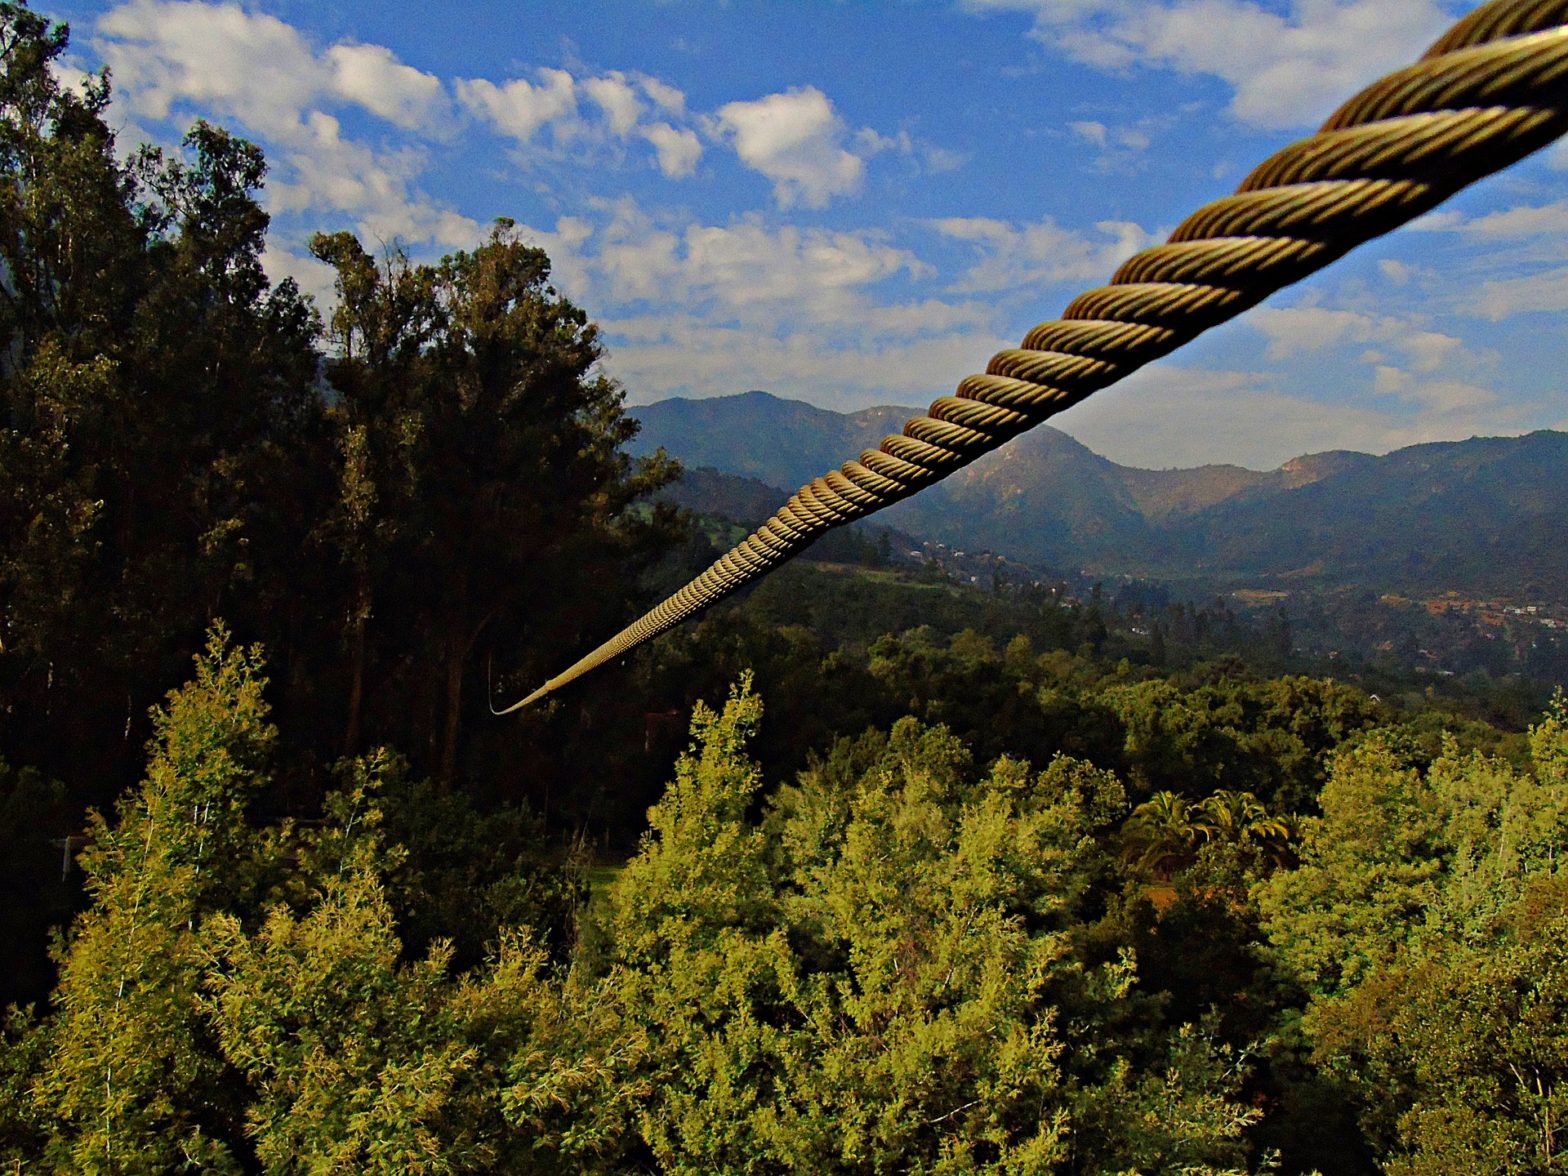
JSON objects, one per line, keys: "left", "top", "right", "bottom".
{"left": 12, "top": 608, "right": 1568, "bottom": 1176}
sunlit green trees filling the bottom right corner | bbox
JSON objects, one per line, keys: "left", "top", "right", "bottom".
{"left": 1259, "top": 702, "right": 1568, "bottom": 1174}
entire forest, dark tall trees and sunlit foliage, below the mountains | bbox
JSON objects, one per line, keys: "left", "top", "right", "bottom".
{"left": 0, "top": 3, "right": 1568, "bottom": 1176}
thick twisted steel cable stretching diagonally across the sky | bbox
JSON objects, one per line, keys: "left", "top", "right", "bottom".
{"left": 499, "top": 0, "right": 1568, "bottom": 713}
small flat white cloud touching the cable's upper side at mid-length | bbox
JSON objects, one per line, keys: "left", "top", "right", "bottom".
{"left": 930, "top": 216, "right": 1154, "bottom": 293}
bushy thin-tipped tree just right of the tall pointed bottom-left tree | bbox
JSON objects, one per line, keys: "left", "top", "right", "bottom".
{"left": 201, "top": 754, "right": 544, "bottom": 1174}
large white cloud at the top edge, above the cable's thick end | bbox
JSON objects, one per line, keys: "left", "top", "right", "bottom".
{"left": 966, "top": 0, "right": 1452, "bottom": 129}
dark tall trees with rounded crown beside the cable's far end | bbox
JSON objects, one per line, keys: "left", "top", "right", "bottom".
{"left": 312, "top": 221, "right": 676, "bottom": 784}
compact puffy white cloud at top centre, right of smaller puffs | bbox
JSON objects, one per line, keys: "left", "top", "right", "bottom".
{"left": 717, "top": 86, "right": 866, "bottom": 209}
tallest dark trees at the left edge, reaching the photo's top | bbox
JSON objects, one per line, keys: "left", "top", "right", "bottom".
{"left": 0, "top": 3, "right": 326, "bottom": 795}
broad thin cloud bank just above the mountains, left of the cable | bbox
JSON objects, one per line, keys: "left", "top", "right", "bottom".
{"left": 552, "top": 199, "right": 1008, "bottom": 408}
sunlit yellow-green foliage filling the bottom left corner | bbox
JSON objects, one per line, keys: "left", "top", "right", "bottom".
{"left": 12, "top": 629, "right": 586, "bottom": 1173}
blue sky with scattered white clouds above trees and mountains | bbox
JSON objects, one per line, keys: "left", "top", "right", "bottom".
{"left": 38, "top": 0, "right": 1568, "bottom": 469}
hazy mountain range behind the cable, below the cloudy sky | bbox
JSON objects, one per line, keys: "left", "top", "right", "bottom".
{"left": 632, "top": 392, "right": 1568, "bottom": 602}
